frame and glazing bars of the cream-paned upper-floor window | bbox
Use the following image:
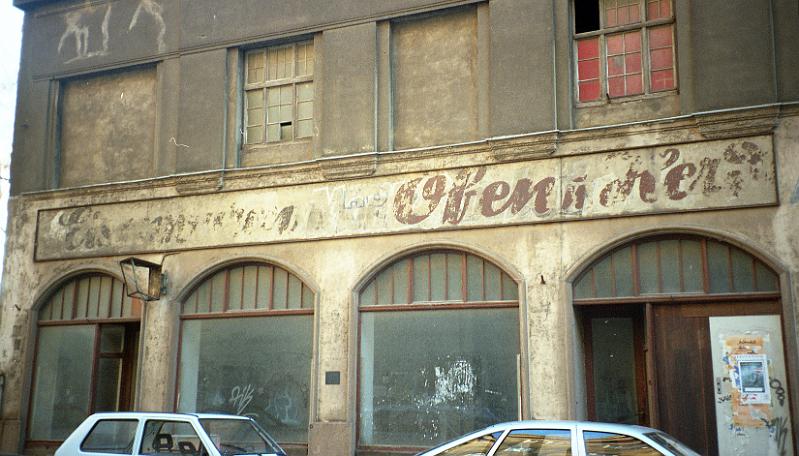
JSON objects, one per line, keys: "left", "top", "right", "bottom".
{"left": 241, "top": 37, "right": 317, "bottom": 147}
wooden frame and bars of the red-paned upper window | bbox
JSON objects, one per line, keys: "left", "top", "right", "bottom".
{"left": 571, "top": 0, "right": 679, "bottom": 107}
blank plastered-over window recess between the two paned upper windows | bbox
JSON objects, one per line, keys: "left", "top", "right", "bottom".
{"left": 392, "top": 8, "right": 477, "bottom": 149}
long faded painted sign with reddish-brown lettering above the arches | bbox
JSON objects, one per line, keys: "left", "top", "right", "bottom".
{"left": 36, "top": 136, "right": 777, "bottom": 260}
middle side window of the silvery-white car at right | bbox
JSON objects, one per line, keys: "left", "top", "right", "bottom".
{"left": 494, "top": 429, "right": 572, "bottom": 456}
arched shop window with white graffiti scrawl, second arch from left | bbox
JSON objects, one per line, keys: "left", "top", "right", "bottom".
{"left": 177, "top": 263, "right": 314, "bottom": 445}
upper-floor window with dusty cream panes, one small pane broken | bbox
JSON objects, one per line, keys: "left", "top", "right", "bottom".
{"left": 244, "top": 41, "right": 314, "bottom": 145}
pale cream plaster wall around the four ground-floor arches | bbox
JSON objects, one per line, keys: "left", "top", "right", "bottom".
{"left": 0, "top": 108, "right": 799, "bottom": 454}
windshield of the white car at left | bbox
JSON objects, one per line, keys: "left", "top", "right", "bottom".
{"left": 200, "top": 418, "right": 284, "bottom": 456}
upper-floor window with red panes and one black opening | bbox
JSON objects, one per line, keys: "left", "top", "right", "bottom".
{"left": 574, "top": 0, "right": 677, "bottom": 103}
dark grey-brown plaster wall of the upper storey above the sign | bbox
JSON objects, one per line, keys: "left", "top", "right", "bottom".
{"left": 12, "top": 0, "right": 799, "bottom": 194}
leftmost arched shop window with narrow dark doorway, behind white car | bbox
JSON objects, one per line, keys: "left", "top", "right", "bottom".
{"left": 28, "top": 274, "right": 141, "bottom": 441}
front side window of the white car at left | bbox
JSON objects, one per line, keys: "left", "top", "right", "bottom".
{"left": 140, "top": 420, "right": 208, "bottom": 456}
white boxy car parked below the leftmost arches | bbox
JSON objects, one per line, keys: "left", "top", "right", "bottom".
{"left": 55, "top": 412, "right": 286, "bottom": 456}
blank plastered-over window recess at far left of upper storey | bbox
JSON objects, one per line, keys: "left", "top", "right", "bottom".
{"left": 59, "top": 67, "right": 156, "bottom": 187}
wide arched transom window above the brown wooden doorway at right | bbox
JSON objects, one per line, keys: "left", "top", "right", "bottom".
{"left": 574, "top": 238, "right": 779, "bottom": 301}
